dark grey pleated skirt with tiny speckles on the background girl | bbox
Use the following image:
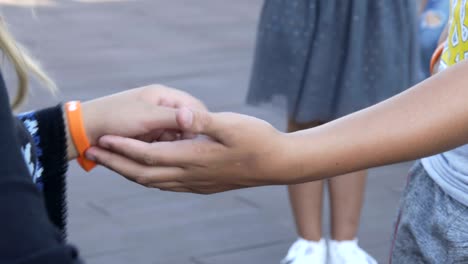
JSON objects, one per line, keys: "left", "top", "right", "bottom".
{"left": 247, "top": 0, "right": 419, "bottom": 122}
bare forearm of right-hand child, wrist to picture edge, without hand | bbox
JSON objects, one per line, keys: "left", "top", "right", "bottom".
{"left": 287, "top": 62, "right": 468, "bottom": 182}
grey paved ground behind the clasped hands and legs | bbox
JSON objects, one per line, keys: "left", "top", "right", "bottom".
{"left": 0, "top": 0, "right": 409, "bottom": 264}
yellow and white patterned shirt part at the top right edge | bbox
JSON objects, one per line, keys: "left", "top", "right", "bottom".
{"left": 440, "top": 0, "right": 468, "bottom": 69}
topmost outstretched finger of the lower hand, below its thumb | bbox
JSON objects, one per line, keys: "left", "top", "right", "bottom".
{"left": 98, "top": 136, "right": 223, "bottom": 167}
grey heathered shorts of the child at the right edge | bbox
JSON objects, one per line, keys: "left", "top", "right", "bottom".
{"left": 390, "top": 162, "right": 468, "bottom": 264}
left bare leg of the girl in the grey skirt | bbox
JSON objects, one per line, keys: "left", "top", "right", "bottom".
{"left": 288, "top": 121, "right": 323, "bottom": 241}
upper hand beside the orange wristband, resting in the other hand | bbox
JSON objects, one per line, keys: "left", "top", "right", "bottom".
{"left": 67, "top": 85, "right": 206, "bottom": 159}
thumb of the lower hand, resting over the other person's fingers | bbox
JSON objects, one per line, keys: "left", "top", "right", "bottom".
{"left": 177, "top": 107, "right": 229, "bottom": 141}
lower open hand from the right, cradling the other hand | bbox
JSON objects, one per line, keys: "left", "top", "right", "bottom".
{"left": 86, "top": 108, "right": 290, "bottom": 194}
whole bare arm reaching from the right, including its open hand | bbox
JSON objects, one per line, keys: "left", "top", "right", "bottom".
{"left": 87, "top": 62, "right": 468, "bottom": 193}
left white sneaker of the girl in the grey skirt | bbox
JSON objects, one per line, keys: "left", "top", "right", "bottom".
{"left": 281, "top": 238, "right": 327, "bottom": 264}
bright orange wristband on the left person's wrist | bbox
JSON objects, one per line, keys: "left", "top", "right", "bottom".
{"left": 65, "top": 101, "right": 96, "bottom": 171}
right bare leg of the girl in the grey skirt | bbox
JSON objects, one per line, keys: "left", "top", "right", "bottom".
{"left": 328, "top": 171, "right": 367, "bottom": 241}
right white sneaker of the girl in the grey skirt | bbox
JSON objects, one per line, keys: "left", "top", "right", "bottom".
{"left": 328, "top": 239, "right": 377, "bottom": 264}
